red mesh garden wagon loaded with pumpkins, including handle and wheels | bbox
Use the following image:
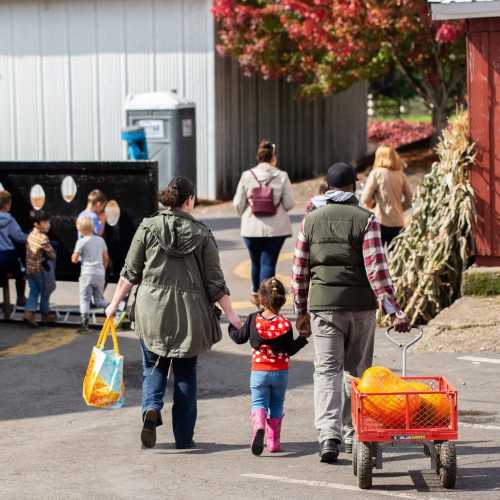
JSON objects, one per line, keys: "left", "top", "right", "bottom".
{"left": 351, "top": 329, "right": 458, "bottom": 489}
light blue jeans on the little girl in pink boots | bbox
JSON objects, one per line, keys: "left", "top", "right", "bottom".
{"left": 250, "top": 370, "right": 288, "bottom": 418}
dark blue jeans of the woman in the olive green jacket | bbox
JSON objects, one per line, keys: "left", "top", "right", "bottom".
{"left": 141, "top": 340, "right": 198, "bottom": 448}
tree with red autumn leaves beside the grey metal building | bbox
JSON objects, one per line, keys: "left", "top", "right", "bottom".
{"left": 213, "top": 0, "right": 465, "bottom": 135}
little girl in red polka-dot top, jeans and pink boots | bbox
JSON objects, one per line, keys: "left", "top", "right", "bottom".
{"left": 229, "top": 278, "right": 307, "bottom": 455}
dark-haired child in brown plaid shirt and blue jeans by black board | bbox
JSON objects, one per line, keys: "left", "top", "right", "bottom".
{"left": 24, "top": 210, "right": 56, "bottom": 326}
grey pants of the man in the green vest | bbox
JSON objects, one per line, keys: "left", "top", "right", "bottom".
{"left": 311, "top": 311, "right": 376, "bottom": 443}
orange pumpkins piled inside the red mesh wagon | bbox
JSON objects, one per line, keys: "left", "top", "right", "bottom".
{"left": 357, "top": 366, "right": 450, "bottom": 429}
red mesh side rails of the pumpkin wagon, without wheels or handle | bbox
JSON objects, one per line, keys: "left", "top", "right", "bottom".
{"left": 352, "top": 377, "right": 458, "bottom": 442}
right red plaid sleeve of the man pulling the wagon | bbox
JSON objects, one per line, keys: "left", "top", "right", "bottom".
{"left": 363, "top": 216, "right": 401, "bottom": 314}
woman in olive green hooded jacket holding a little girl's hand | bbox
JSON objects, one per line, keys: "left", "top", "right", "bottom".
{"left": 106, "top": 177, "right": 241, "bottom": 448}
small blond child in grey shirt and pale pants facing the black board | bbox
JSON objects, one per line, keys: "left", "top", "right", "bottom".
{"left": 71, "top": 216, "right": 109, "bottom": 333}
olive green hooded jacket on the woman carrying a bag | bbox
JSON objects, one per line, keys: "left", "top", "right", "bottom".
{"left": 121, "top": 210, "right": 229, "bottom": 358}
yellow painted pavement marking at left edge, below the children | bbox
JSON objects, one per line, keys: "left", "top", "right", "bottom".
{"left": 0, "top": 328, "right": 79, "bottom": 358}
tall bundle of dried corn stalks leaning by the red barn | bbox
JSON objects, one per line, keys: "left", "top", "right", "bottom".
{"left": 389, "top": 112, "right": 475, "bottom": 324}
